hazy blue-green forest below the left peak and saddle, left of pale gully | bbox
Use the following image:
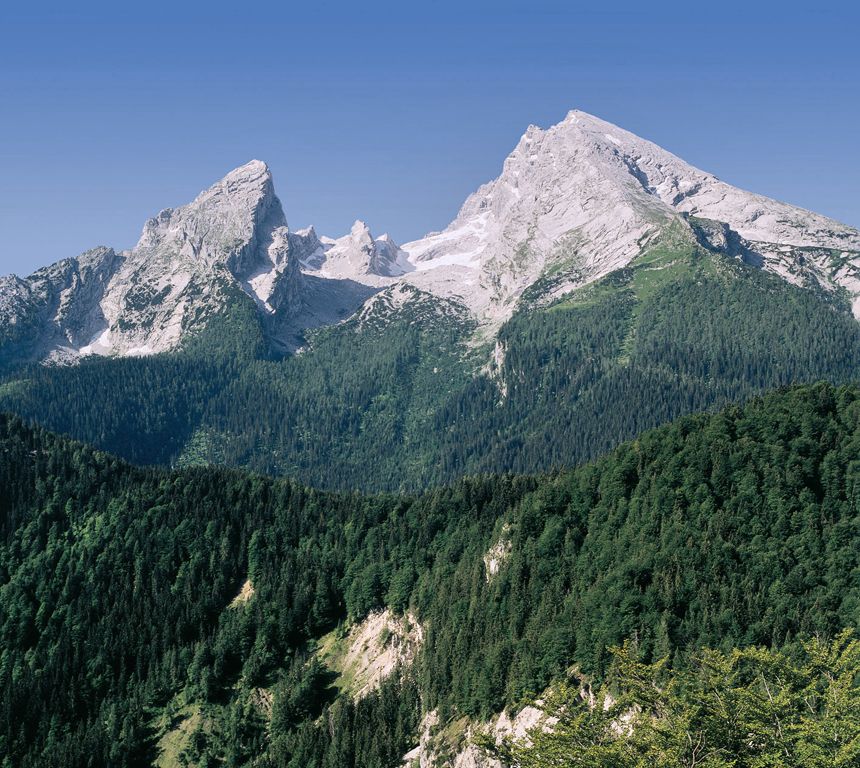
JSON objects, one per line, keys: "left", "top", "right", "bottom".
{"left": 0, "top": 298, "right": 468, "bottom": 488}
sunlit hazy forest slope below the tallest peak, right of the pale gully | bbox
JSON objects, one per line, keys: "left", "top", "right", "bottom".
{"left": 433, "top": 254, "right": 860, "bottom": 473}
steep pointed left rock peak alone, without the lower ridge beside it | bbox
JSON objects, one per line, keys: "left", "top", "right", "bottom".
{"left": 95, "top": 161, "right": 300, "bottom": 355}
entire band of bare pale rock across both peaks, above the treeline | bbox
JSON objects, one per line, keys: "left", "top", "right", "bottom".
{"left": 5, "top": 111, "right": 860, "bottom": 368}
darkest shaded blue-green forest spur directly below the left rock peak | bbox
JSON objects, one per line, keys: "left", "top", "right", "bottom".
{"left": 0, "top": 285, "right": 265, "bottom": 464}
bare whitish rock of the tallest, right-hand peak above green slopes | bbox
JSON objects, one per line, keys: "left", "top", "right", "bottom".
{"left": 403, "top": 111, "right": 860, "bottom": 322}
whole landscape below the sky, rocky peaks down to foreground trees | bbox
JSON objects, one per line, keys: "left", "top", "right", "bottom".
{"left": 5, "top": 111, "right": 860, "bottom": 768}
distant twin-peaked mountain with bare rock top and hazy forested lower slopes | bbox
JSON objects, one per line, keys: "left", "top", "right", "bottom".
{"left": 0, "top": 113, "right": 860, "bottom": 491}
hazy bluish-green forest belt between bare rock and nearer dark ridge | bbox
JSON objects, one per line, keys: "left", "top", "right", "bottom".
{"left": 6, "top": 246, "right": 860, "bottom": 492}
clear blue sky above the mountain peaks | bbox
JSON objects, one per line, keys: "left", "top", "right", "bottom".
{"left": 0, "top": 0, "right": 860, "bottom": 274}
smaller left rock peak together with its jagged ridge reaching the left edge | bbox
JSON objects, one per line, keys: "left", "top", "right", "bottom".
{"left": 0, "top": 160, "right": 304, "bottom": 360}
